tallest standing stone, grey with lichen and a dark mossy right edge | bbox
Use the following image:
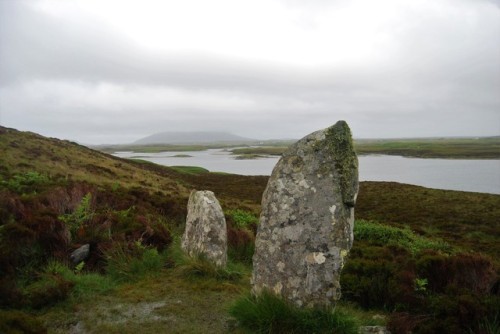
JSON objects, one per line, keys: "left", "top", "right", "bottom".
{"left": 252, "top": 121, "right": 358, "bottom": 307}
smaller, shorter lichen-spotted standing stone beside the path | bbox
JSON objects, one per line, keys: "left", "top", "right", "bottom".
{"left": 181, "top": 190, "right": 227, "bottom": 267}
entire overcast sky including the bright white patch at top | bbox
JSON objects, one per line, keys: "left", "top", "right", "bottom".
{"left": 0, "top": 0, "right": 500, "bottom": 144}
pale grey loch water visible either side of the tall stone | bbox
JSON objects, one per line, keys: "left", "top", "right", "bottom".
{"left": 114, "top": 149, "right": 500, "bottom": 194}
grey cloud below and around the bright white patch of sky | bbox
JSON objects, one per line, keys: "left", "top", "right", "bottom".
{"left": 0, "top": 0, "right": 500, "bottom": 143}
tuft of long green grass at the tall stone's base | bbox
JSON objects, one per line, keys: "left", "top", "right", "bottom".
{"left": 229, "top": 292, "right": 359, "bottom": 334}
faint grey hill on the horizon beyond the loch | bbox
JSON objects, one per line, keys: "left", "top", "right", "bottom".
{"left": 133, "top": 131, "right": 256, "bottom": 145}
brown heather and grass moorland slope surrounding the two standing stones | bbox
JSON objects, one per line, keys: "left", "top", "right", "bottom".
{"left": 0, "top": 128, "right": 500, "bottom": 333}
